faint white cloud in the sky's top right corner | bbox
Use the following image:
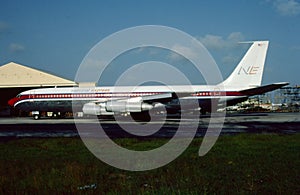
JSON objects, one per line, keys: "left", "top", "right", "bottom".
{"left": 268, "top": 0, "right": 300, "bottom": 16}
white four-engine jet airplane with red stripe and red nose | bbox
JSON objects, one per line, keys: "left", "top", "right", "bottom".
{"left": 8, "top": 41, "right": 289, "bottom": 121}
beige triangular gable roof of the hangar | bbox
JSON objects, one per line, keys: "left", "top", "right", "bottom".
{"left": 0, "top": 62, "right": 77, "bottom": 88}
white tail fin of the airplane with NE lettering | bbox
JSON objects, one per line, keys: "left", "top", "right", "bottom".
{"left": 221, "top": 41, "right": 269, "bottom": 90}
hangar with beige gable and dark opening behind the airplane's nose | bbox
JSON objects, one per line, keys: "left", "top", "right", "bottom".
{"left": 0, "top": 62, "right": 77, "bottom": 115}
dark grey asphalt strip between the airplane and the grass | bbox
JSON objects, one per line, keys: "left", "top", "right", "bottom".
{"left": 0, "top": 113, "right": 300, "bottom": 139}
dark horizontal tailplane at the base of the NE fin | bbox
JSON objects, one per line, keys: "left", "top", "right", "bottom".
{"left": 240, "top": 82, "right": 289, "bottom": 96}
